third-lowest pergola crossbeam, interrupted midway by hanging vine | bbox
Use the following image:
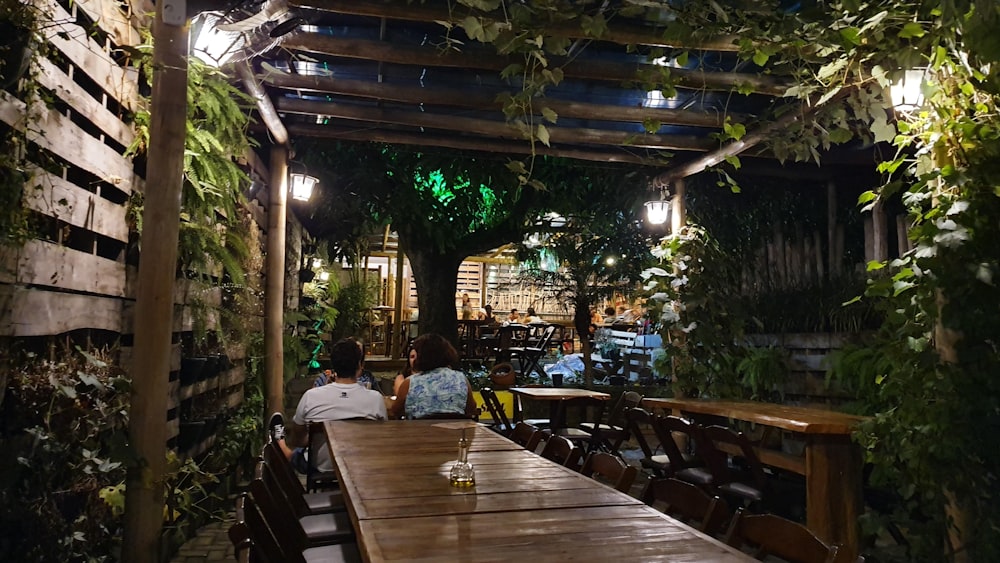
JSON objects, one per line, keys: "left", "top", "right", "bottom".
{"left": 258, "top": 72, "right": 750, "bottom": 129}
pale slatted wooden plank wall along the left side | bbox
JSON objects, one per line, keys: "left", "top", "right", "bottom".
{"left": 0, "top": 0, "right": 268, "bottom": 454}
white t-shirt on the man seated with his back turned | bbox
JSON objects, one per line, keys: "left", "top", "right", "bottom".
{"left": 292, "top": 382, "right": 386, "bottom": 471}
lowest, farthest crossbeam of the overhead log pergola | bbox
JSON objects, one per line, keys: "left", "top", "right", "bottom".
{"left": 278, "top": 125, "right": 688, "bottom": 166}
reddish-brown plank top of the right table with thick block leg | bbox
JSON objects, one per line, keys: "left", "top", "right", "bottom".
{"left": 642, "top": 397, "right": 865, "bottom": 435}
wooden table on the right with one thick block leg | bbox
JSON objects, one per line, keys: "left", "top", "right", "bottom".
{"left": 642, "top": 397, "right": 864, "bottom": 556}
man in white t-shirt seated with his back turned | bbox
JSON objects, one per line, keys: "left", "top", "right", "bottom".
{"left": 268, "top": 338, "right": 386, "bottom": 473}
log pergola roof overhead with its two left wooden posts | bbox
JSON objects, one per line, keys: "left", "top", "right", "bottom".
{"left": 124, "top": 0, "right": 884, "bottom": 561}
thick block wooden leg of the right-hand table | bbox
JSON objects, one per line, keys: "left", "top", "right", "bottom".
{"left": 806, "top": 434, "right": 863, "bottom": 561}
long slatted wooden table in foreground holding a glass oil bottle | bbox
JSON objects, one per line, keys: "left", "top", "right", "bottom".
{"left": 326, "top": 420, "right": 753, "bottom": 563}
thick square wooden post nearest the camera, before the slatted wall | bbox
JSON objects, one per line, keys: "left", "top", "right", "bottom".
{"left": 122, "top": 6, "right": 188, "bottom": 561}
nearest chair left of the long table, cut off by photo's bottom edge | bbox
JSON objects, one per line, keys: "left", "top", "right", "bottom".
{"left": 229, "top": 494, "right": 362, "bottom": 563}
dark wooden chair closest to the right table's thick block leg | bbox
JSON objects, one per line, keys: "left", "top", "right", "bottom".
{"left": 702, "top": 425, "right": 767, "bottom": 511}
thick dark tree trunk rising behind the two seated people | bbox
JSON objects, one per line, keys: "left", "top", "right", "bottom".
{"left": 406, "top": 245, "right": 465, "bottom": 344}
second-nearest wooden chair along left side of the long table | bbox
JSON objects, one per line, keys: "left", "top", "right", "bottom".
{"left": 250, "top": 462, "right": 354, "bottom": 550}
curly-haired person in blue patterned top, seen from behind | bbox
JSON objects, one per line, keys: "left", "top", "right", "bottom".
{"left": 389, "top": 333, "right": 476, "bottom": 418}
